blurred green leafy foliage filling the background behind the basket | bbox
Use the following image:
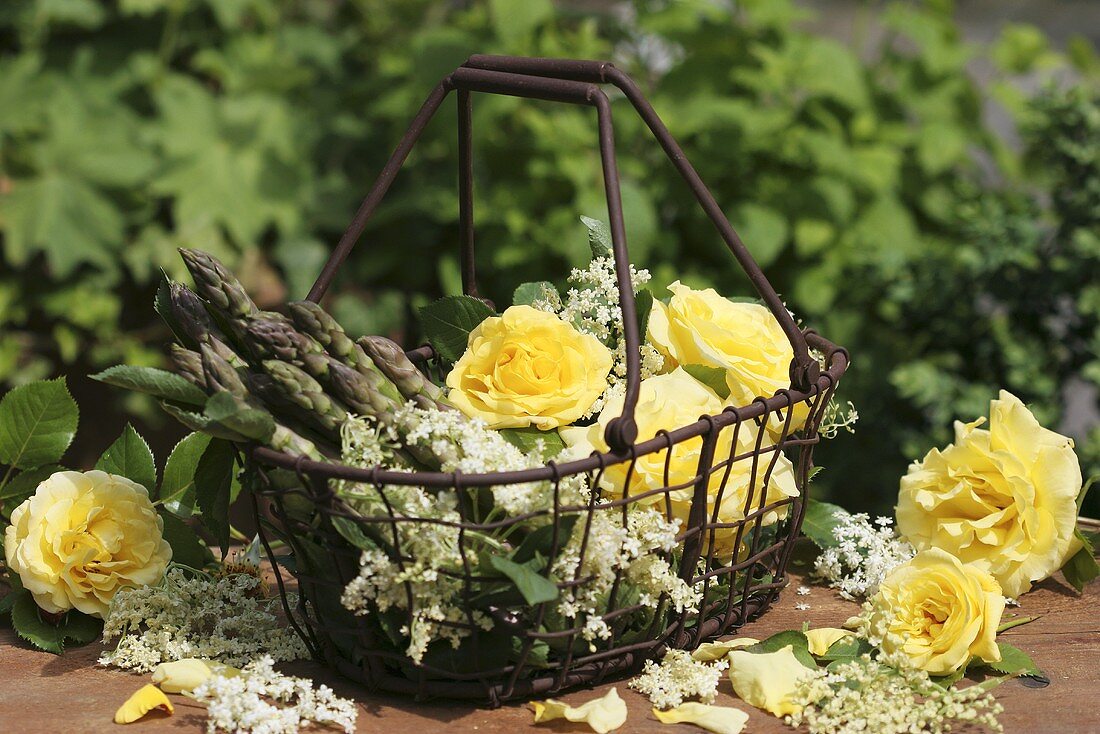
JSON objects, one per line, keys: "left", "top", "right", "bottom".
{"left": 0, "top": 0, "right": 1100, "bottom": 510}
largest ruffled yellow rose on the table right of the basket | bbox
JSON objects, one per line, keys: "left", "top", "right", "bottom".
{"left": 898, "top": 391, "right": 1081, "bottom": 598}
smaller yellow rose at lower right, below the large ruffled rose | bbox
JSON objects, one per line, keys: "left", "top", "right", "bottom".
{"left": 868, "top": 548, "right": 1004, "bottom": 676}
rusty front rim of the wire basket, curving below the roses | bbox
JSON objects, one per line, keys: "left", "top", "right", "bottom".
{"left": 246, "top": 330, "right": 850, "bottom": 487}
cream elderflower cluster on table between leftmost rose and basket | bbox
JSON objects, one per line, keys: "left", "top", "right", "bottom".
{"left": 99, "top": 568, "right": 308, "bottom": 672}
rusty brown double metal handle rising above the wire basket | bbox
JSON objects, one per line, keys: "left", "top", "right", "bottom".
{"left": 307, "top": 55, "right": 820, "bottom": 452}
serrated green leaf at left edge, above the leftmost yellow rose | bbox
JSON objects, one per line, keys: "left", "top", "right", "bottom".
{"left": 0, "top": 377, "right": 80, "bottom": 469}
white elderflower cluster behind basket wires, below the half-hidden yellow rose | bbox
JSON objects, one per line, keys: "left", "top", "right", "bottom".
{"left": 553, "top": 507, "right": 700, "bottom": 642}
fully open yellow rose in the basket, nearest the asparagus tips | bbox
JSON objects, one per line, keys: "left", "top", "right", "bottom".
{"left": 447, "top": 306, "right": 612, "bottom": 430}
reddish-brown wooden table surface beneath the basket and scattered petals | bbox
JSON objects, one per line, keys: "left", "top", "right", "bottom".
{"left": 0, "top": 550, "right": 1100, "bottom": 734}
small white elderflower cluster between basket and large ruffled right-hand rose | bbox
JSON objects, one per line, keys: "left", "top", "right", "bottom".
{"left": 814, "top": 512, "right": 915, "bottom": 600}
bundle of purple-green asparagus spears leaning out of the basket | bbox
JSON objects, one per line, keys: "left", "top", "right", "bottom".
{"left": 162, "top": 250, "right": 453, "bottom": 469}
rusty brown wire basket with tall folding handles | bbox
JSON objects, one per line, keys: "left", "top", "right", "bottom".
{"left": 246, "top": 56, "right": 848, "bottom": 705}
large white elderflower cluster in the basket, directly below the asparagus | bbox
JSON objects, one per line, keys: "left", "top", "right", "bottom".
{"left": 338, "top": 411, "right": 584, "bottom": 662}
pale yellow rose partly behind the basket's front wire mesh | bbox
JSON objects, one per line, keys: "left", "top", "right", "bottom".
{"left": 561, "top": 368, "right": 799, "bottom": 560}
